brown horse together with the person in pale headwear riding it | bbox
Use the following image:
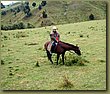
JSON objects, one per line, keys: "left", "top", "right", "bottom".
{"left": 44, "top": 26, "right": 81, "bottom": 65}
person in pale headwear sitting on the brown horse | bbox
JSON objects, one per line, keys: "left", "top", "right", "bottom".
{"left": 48, "top": 26, "right": 60, "bottom": 54}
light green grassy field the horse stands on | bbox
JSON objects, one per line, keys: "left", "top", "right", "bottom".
{"left": 0, "top": 20, "right": 106, "bottom": 90}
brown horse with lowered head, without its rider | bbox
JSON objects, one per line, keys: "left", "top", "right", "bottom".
{"left": 44, "top": 41, "right": 81, "bottom": 65}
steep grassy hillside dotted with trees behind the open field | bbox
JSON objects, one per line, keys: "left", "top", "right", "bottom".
{"left": 1, "top": 1, "right": 106, "bottom": 27}
